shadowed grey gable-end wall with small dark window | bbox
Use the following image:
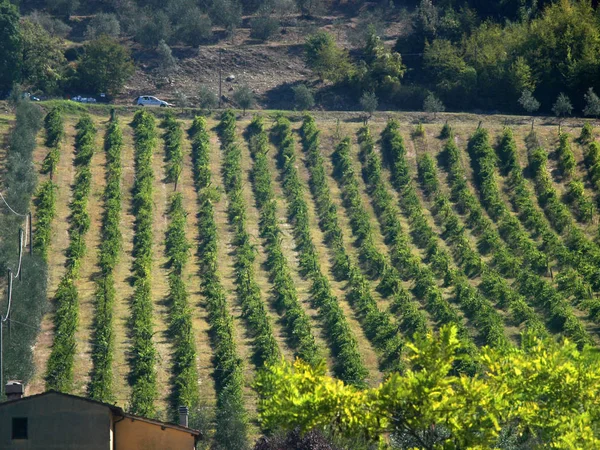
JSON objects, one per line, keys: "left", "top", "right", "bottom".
{"left": 0, "top": 393, "right": 111, "bottom": 450}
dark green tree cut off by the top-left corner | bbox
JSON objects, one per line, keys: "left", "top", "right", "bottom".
{"left": 0, "top": 0, "right": 22, "bottom": 96}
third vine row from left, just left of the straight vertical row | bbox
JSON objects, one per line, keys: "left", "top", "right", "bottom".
{"left": 88, "top": 115, "right": 123, "bottom": 402}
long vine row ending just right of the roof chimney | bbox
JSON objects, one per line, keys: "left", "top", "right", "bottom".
{"left": 190, "top": 117, "right": 246, "bottom": 446}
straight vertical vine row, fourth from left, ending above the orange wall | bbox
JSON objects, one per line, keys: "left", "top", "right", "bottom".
{"left": 129, "top": 110, "right": 158, "bottom": 417}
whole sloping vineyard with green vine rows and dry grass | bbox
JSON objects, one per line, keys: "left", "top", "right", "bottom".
{"left": 1, "top": 109, "right": 600, "bottom": 448}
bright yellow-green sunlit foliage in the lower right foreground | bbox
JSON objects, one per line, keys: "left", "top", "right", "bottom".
{"left": 256, "top": 326, "right": 600, "bottom": 449}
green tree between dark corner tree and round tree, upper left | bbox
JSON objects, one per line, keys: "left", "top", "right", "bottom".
{"left": 21, "top": 19, "right": 66, "bottom": 94}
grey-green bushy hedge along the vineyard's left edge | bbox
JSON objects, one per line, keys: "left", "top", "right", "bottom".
{"left": 0, "top": 101, "right": 47, "bottom": 383}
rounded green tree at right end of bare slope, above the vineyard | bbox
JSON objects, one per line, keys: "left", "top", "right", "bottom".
{"left": 304, "top": 31, "right": 351, "bottom": 83}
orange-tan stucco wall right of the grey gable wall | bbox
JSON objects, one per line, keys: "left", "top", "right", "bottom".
{"left": 115, "top": 418, "right": 194, "bottom": 450}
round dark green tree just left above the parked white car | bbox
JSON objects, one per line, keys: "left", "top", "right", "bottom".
{"left": 77, "top": 36, "right": 135, "bottom": 95}
